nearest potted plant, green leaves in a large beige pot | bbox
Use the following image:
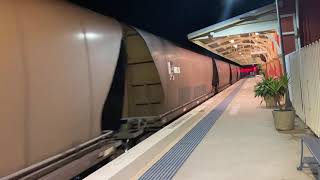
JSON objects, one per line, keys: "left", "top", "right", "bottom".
{"left": 267, "top": 76, "right": 296, "bottom": 130}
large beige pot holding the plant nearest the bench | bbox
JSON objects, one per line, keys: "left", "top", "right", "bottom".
{"left": 272, "top": 110, "right": 296, "bottom": 131}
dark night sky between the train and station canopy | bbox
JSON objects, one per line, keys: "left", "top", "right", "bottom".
{"left": 70, "top": 0, "right": 274, "bottom": 64}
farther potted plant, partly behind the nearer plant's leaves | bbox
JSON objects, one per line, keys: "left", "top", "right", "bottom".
{"left": 254, "top": 78, "right": 277, "bottom": 108}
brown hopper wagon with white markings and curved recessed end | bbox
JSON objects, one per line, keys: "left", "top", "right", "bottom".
{"left": 111, "top": 26, "right": 214, "bottom": 126}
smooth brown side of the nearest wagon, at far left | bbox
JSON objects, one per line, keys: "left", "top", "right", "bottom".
{"left": 0, "top": 1, "right": 122, "bottom": 177}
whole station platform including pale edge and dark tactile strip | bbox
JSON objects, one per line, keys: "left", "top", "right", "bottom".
{"left": 87, "top": 78, "right": 314, "bottom": 180}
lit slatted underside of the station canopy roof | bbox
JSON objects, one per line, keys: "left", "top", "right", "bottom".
{"left": 192, "top": 31, "right": 276, "bottom": 65}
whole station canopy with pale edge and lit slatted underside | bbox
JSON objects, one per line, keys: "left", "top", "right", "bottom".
{"left": 188, "top": 4, "right": 280, "bottom": 65}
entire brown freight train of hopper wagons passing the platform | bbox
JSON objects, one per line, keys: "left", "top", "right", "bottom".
{"left": 0, "top": 1, "right": 240, "bottom": 178}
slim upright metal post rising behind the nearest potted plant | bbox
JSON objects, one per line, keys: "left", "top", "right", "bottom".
{"left": 275, "top": 0, "right": 292, "bottom": 108}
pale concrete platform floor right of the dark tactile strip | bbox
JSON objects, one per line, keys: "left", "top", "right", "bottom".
{"left": 173, "top": 78, "right": 314, "bottom": 180}
